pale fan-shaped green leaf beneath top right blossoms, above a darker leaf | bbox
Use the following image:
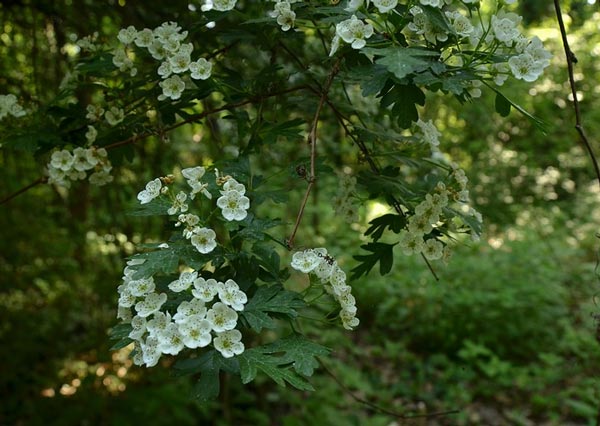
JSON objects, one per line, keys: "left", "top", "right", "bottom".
{"left": 361, "top": 46, "right": 439, "bottom": 80}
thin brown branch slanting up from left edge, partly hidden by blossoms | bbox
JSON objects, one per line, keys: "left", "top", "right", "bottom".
{"left": 0, "top": 86, "right": 308, "bottom": 205}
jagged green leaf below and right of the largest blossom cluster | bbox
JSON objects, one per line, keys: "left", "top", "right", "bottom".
{"left": 238, "top": 334, "right": 330, "bottom": 391}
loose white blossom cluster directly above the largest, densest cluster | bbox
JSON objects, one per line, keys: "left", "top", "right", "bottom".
{"left": 137, "top": 166, "right": 250, "bottom": 254}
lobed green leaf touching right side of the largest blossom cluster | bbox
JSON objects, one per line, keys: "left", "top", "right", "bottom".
{"left": 240, "top": 284, "right": 306, "bottom": 332}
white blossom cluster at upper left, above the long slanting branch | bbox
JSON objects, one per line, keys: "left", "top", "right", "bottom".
{"left": 113, "top": 22, "right": 214, "bottom": 100}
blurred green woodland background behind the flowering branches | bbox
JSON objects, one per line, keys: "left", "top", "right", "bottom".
{"left": 0, "top": 0, "right": 600, "bottom": 426}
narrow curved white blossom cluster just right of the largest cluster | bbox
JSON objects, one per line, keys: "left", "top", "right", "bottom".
{"left": 291, "top": 247, "right": 360, "bottom": 330}
